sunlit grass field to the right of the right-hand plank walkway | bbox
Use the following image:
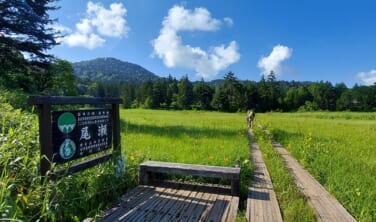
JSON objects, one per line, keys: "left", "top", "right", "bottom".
{"left": 257, "top": 112, "right": 376, "bottom": 221}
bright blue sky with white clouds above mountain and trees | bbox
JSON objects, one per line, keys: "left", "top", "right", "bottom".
{"left": 51, "top": 0, "right": 376, "bottom": 87}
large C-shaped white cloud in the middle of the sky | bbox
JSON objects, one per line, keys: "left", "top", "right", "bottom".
{"left": 152, "top": 6, "right": 240, "bottom": 79}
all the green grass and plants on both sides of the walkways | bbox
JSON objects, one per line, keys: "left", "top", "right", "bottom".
{"left": 0, "top": 105, "right": 376, "bottom": 221}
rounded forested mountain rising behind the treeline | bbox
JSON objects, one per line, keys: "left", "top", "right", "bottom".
{"left": 72, "top": 58, "right": 159, "bottom": 83}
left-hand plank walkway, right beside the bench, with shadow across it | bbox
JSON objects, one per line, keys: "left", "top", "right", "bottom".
{"left": 246, "top": 129, "right": 282, "bottom": 222}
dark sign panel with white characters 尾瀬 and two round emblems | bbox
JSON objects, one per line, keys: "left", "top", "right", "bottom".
{"left": 52, "top": 109, "right": 112, "bottom": 163}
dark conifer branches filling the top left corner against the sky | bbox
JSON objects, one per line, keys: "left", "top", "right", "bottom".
{"left": 0, "top": 0, "right": 59, "bottom": 63}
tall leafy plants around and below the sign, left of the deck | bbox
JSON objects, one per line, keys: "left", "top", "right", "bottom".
{"left": 0, "top": 103, "right": 135, "bottom": 221}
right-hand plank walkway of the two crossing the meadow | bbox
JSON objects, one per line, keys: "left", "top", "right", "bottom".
{"left": 272, "top": 142, "right": 356, "bottom": 222}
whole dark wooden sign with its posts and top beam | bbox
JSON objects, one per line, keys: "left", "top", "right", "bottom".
{"left": 28, "top": 96, "right": 122, "bottom": 176}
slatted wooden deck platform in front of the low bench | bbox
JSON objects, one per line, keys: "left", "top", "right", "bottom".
{"left": 97, "top": 181, "right": 239, "bottom": 222}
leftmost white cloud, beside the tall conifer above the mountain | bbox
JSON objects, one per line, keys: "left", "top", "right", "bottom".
{"left": 58, "top": 1, "right": 129, "bottom": 49}
